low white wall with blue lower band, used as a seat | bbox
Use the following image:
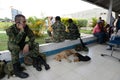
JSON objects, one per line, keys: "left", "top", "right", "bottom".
{"left": 0, "top": 35, "right": 97, "bottom": 61}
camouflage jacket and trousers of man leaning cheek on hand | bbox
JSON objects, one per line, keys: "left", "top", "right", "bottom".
{"left": 6, "top": 24, "right": 45, "bottom": 64}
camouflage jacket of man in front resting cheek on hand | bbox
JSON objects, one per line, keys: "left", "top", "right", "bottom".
{"left": 6, "top": 24, "right": 35, "bottom": 45}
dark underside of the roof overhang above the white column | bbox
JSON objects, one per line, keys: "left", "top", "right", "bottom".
{"left": 82, "top": 0, "right": 120, "bottom": 13}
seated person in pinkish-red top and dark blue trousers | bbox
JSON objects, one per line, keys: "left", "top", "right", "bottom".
{"left": 93, "top": 21, "right": 106, "bottom": 44}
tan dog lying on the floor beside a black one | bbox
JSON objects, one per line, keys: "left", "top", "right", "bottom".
{"left": 54, "top": 49, "right": 77, "bottom": 62}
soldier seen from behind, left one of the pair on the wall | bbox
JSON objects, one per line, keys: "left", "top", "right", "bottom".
{"left": 46, "top": 16, "right": 66, "bottom": 43}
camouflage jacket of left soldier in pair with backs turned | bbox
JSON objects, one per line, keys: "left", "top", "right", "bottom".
{"left": 51, "top": 21, "right": 66, "bottom": 39}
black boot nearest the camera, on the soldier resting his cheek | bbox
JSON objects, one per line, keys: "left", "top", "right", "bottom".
{"left": 13, "top": 62, "right": 29, "bottom": 78}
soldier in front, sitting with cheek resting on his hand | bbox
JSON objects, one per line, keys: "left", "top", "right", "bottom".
{"left": 6, "top": 14, "right": 50, "bottom": 78}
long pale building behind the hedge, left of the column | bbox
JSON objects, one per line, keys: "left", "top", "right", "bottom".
{"left": 62, "top": 8, "right": 114, "bottom": 20}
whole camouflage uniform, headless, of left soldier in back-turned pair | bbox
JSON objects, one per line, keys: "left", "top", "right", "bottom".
{"left": 51, "top": 21, "right": 66, "bottom": 42}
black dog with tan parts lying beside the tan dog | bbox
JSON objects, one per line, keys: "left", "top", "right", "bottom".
{"left": 73, "top": 53, "right": 91, "bottom": 62}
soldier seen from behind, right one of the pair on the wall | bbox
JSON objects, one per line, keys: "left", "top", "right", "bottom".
{"left": 66, "top": 19, "right": 80, "bottom": 40}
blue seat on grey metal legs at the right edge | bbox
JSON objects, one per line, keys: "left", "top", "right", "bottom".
{"left": 101, "top": 37, "right": 120, "bottom": 61}
